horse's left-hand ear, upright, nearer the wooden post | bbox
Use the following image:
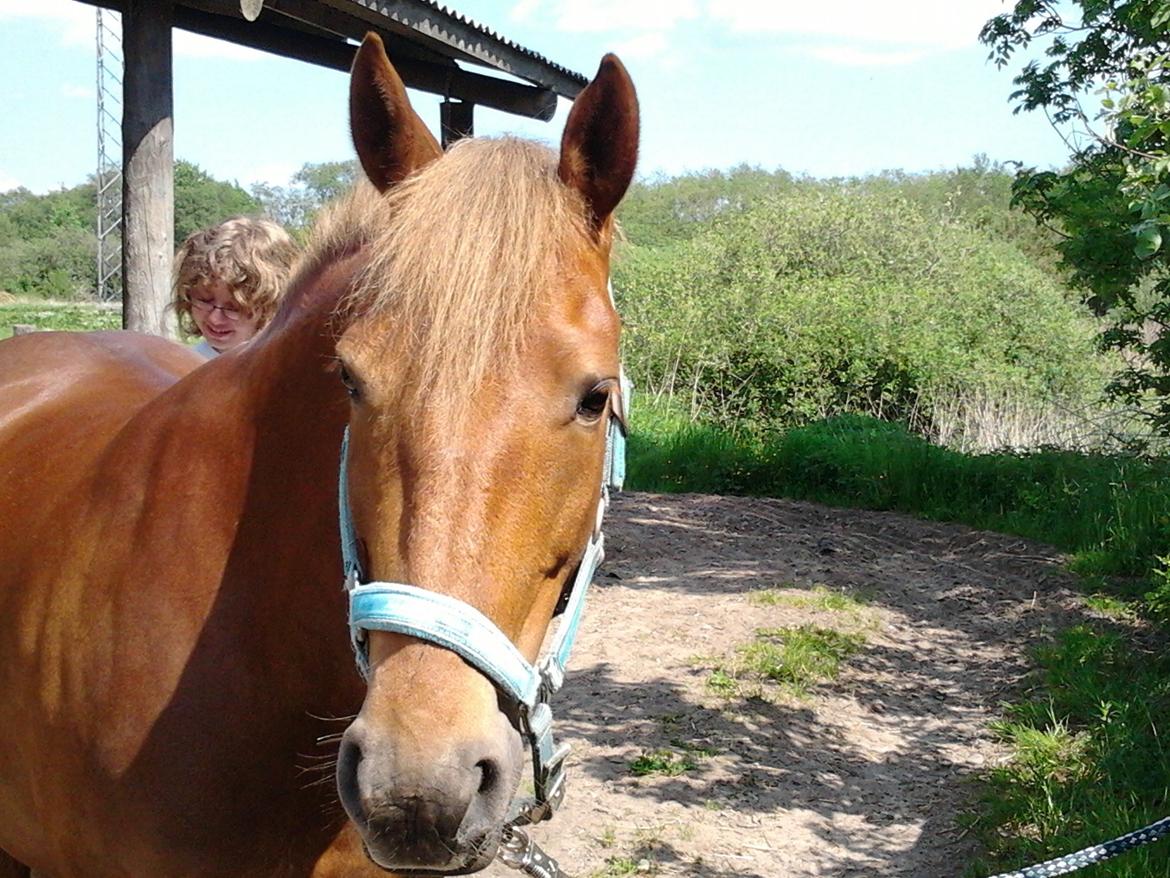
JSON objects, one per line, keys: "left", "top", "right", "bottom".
{"left": 350, "top": 33, "right": 442, "bottom": 192}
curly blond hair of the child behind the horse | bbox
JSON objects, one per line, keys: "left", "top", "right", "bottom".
{"left": 171, "top": 217, "right": 300, "bottom": 336}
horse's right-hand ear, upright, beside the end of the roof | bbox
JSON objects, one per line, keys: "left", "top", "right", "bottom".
{"left": 557, "top": 54, "right": 638, "bottom": 229}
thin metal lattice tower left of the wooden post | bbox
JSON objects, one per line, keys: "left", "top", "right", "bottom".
{"left": 94, "top": 8, "right": 123, "bottom": 300}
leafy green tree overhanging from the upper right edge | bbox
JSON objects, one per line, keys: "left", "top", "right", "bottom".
{"left": 982, "top": 0, "right": 1170, "bottom": 433}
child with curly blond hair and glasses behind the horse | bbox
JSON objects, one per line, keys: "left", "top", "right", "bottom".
{"left": 172, "top": 217, "right": 298, "bottom": 358}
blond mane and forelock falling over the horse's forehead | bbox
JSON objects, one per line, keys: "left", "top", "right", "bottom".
{"left": 305, "top": 137, "right": 590, "bottom": 407}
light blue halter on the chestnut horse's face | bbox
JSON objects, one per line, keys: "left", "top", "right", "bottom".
{"left": 338, "top": 371, "right": 632, "bottom": 823}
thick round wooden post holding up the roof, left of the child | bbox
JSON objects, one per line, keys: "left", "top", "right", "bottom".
{"left": 122, "top": 0, "right": 176, "bottom": 337}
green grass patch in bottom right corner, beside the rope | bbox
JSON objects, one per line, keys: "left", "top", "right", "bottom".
{"left": 969, "top": 625, "right": 1170, "bottom": 878}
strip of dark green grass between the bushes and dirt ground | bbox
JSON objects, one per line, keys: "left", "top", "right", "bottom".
{"left": 628, "top": 403, "right": 1170, "bottom": 576}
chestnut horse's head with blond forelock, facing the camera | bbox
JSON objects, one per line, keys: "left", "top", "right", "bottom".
{"left": 337, "top": 36, "right": 638, "bottom": 873}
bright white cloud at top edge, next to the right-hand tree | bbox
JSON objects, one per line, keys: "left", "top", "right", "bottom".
{"left": 707, "top": 0, "right": 1005, "bottom": 49}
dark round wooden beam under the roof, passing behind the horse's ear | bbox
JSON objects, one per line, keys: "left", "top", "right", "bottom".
{"left": 174, "top": 6, "right": 557, "bottom": 122}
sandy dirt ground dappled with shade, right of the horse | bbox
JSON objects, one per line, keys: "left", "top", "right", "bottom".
{"left": 484, "top": 494, "right": 1087, "bottom": 878}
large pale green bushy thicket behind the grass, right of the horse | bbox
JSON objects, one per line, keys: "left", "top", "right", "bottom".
{"left": 614, "top": 158, "right": 1109, "bottom": 442}
